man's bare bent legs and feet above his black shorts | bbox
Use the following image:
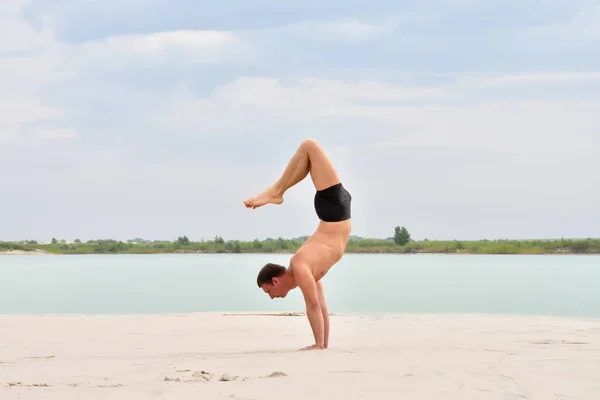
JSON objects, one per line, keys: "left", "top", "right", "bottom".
{"left": 244, "top": 139, "right": 340, "bottom": 208}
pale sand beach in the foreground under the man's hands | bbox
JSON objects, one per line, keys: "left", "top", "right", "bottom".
{"left": 0, "top": 313, "right": 600, "bottom": 400}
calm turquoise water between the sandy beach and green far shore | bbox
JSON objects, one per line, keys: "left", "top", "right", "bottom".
{"left": 0, "top": 254, "right": 600, "bottom": 317}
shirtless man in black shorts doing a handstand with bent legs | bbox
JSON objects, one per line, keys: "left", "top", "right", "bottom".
{"left": 244, "top": 139, "right": 352, "bottom": 350}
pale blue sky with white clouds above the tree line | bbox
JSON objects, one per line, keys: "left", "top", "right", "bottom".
{"left": 0, "top": 0, "right": 600, "bottom": 241}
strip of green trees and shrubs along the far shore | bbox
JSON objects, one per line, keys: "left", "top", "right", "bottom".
{"left": 0, "top": 226, "right": 600, "bottom": 254}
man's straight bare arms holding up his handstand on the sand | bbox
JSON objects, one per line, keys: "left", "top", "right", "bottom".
{"left": 294, "top": 263, "right": 325, "bottom": 348}
